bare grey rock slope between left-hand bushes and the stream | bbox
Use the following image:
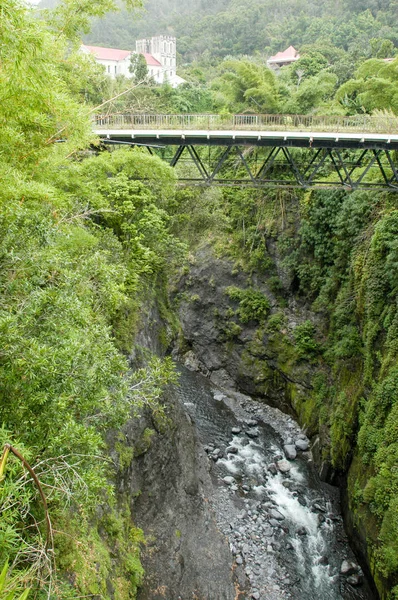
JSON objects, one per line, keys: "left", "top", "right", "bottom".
{"left": 119, "top": 392, "right": 235, "bottom": 600}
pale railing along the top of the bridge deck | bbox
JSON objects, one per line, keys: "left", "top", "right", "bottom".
{"left": 94, "top": 112, "right": 398, "bottom": 134}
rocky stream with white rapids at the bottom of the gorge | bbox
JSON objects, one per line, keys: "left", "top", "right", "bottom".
{"left": 176, "top": 367, "right": 374, "bottom": 600}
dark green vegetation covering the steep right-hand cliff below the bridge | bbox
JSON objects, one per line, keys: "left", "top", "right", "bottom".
{"left": 179, "top": 180, "right": 398, "bottom": 599}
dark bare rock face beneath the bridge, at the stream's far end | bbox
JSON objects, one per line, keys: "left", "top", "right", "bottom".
{"left": 175, "top": 246, "right": 310, "bottom": 414}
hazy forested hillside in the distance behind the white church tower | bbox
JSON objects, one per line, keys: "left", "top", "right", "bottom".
{"left": 35, "top": 0, "right": 398, "bottom": 62}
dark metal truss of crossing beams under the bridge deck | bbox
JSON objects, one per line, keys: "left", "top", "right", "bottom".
{"left": 103, "top": 140, "right": 398, "bottom": 192}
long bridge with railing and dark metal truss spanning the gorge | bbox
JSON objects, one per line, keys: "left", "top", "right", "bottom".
{"left": 94, "top": 114, "right": 398, "bottom": 192}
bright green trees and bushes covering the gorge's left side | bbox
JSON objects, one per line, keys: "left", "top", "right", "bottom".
{"left": 0, "top": 0, "right": 180, "bottom": 599}
